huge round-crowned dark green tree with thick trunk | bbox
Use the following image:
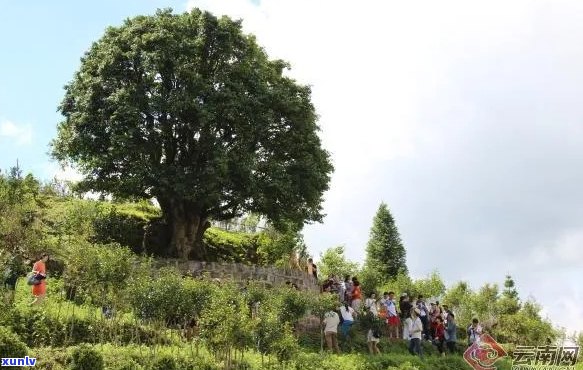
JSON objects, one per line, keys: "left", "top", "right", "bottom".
{"left": 52, "top": 9, "right": 333, "bottom": 258}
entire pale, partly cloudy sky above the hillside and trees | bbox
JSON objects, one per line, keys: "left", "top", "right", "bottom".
{"left": 0, "top": 0, "right": 583, "bottom": 332}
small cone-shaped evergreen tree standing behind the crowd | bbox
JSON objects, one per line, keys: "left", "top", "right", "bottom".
{"left": 365, "top": 203, "right": 408, "bottom": 283}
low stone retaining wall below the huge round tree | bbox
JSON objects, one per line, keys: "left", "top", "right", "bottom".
{"left": 156, "top": 259, "right": 320, "bottom": 292}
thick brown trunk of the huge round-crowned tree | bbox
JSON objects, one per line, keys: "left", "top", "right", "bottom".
{"left": 159, "top": 200, "right": 210, "bottom": 261}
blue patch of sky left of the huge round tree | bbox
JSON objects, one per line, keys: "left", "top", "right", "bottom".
{"left": 0, "top": 0, "right": 185, "bottom": 178}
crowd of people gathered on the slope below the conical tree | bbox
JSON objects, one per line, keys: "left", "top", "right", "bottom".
{"left": 322, "top": 276, "right": 482, "bottom": 357}
